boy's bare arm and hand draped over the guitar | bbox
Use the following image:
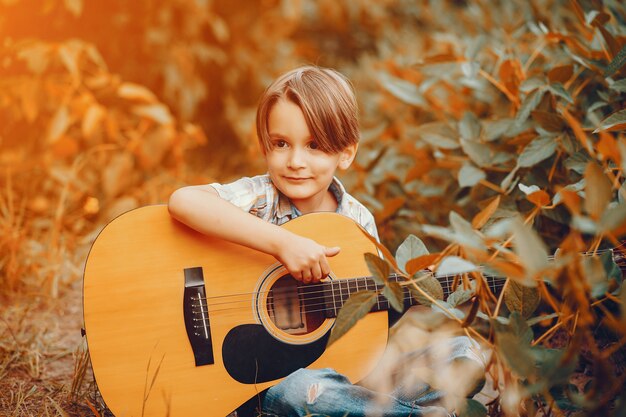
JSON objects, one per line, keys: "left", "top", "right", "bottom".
{"left": 168, "top": 185, "right": 339, "bottom": 283}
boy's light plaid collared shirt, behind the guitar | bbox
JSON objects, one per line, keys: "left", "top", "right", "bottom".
{"left": 209, "top": 174, "right": 378, "bottom": 240}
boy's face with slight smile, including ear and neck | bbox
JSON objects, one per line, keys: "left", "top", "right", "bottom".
{"left": 265, "top": 99, "right": 356, "bottom": 213}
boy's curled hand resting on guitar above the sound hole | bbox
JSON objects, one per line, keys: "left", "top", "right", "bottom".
{"left": 276, "top": 233, "right": 340, "bottom": 284}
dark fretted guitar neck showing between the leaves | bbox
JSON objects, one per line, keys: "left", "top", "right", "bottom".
{"left": 320, "top": 274, "right": 505, "bottom": 318}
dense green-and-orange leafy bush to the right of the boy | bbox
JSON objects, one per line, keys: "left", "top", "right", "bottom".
{"left": 332, "top": 1, "right": 626, "bottom": 416}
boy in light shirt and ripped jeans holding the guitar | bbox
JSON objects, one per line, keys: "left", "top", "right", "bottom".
{"left": 169, "top": 66, "right": 478, "bottom": 416}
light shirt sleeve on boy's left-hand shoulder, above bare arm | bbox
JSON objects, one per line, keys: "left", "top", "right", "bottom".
{"left": 209, "top": 177, "right": 267, "bottom": 217}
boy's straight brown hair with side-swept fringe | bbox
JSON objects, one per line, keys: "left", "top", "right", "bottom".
{"left": 256, "top": 66, "right": 359, "bottom": 153}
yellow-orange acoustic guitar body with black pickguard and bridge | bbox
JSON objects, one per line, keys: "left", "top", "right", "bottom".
{"left": 83, "top": 205, "right": 388, "bottom": 417}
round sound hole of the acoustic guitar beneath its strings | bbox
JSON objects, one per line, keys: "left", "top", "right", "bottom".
{"left": 267, "top": 275, "right": 325, "bottom": 335}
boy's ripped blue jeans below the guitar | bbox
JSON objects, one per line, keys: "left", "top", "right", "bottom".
{"left": 263, "top": 336, "right": 484, "bottom": 417}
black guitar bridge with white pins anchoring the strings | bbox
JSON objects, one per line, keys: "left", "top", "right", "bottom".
{"left": 183, "top": 267, "right": 215, "bottom": 366}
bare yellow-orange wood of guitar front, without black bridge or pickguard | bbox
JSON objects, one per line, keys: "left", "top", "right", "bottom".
{"left": 83, "top": 206, "right": 387, "bottom": 417}
